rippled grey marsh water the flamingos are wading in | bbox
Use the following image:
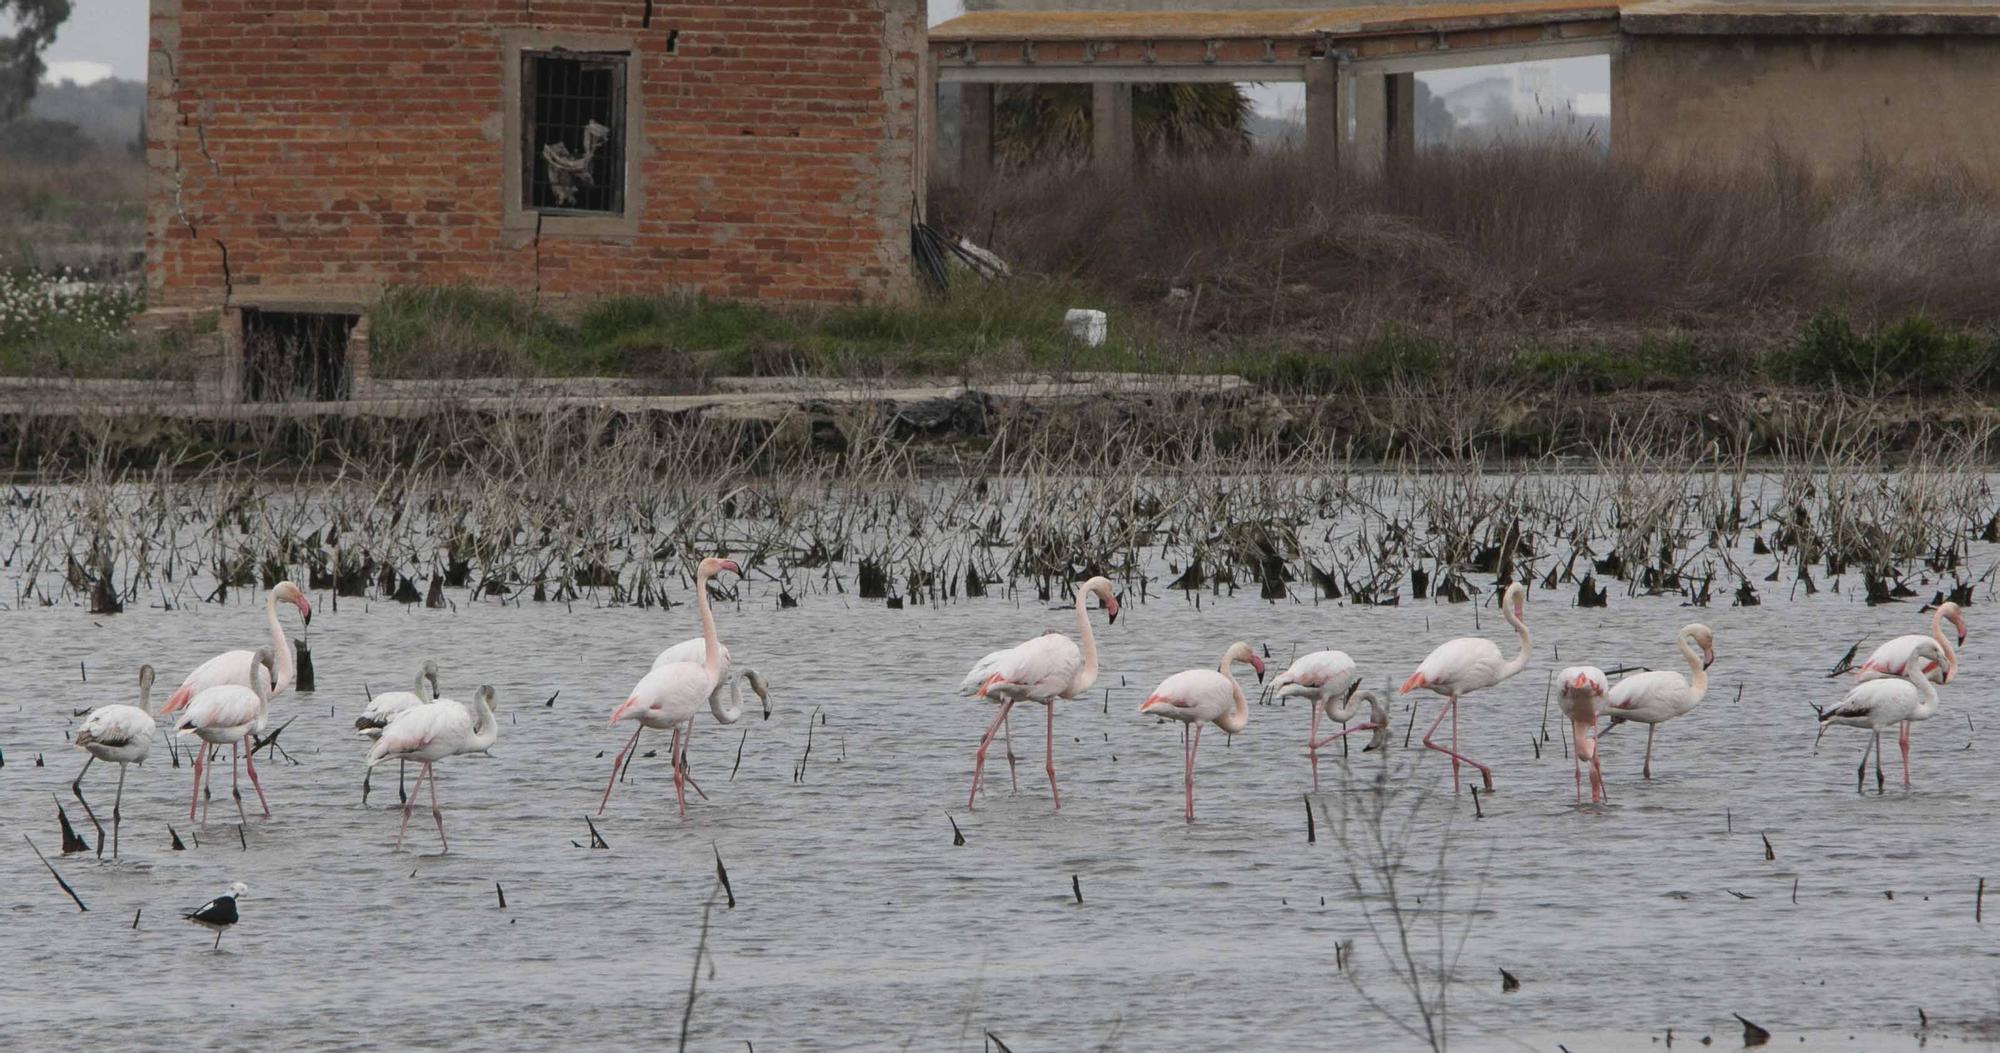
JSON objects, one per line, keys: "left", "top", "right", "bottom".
{"left": 0, "top": 480, "right": 2000, "bottom": 1053}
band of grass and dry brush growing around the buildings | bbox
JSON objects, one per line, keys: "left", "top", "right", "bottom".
{"left": 11, "top": 146, "right": 2000, "bottom": 394}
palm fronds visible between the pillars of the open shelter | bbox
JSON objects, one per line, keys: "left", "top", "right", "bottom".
{"left": 994, "top": 84, "right": 1250, "bottom": 166}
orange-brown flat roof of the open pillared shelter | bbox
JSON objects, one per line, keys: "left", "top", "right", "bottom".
{"left": 930, "top": 0, "right": 1618, "bottom": 44}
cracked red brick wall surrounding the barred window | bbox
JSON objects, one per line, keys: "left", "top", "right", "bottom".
{"left": 148, "top": 0, "right": 924, "bottom": 308}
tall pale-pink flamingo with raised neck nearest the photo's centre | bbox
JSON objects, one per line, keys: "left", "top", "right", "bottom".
{"left": 958, "top": 577, "right": 1118, "bottom": 811}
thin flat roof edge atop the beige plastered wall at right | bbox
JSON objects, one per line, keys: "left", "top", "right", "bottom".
{"left": 1618, "top": 0, "right": 2000, "bottom": 36}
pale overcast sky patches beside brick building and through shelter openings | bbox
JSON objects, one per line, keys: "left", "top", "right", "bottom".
{"left": 44, "top": 0, "right": 1610, "bottom": 112}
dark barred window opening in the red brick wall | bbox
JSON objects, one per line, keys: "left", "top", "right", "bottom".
{"left": 520, "top": 52, "right": 628, "bottom": 216}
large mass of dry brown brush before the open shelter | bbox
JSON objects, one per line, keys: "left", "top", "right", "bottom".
{"left": 932, "top": 142, "right": 2000, "bottom": 336}
